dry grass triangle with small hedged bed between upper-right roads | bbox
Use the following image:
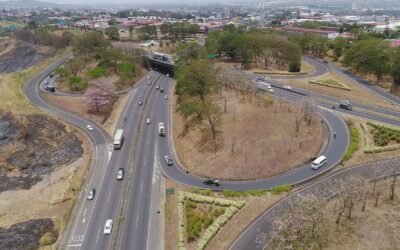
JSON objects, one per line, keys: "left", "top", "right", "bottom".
{"left": 278, "top": 72, "right": 398, "bottom": 109}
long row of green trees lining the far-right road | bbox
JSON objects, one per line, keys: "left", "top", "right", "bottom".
{"left": 288, "top": 27, "right": 400, "bottom": 94}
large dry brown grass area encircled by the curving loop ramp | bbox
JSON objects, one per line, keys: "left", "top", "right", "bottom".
{"left": 173, "top": 87, "right": 324, "bottom": 180}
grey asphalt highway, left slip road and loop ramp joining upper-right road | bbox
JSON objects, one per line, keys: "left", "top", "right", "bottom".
{"left": 24, "top": 57, "right": 400, "bottom": 249}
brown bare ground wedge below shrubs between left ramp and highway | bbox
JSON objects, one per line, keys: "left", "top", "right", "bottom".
{"left": 46, "top": 91, "right": 129, "bottom": 135}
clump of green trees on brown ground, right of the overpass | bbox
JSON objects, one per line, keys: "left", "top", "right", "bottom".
{"left": 205, "top": 25, "right": 301, "bottom": 72}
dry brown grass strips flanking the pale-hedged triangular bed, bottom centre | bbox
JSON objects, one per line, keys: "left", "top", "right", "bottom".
{"left": 164, "top": 180, "right": 285, "bottom": 250}
